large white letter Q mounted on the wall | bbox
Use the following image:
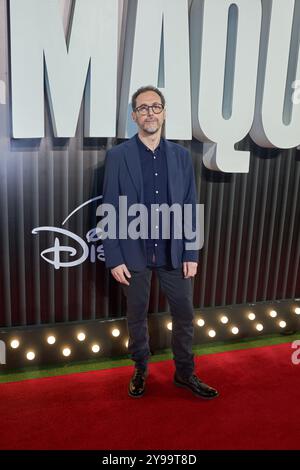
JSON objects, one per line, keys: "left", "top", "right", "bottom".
{"left": 190, "top": 0, "right": 261, "bottom": 173}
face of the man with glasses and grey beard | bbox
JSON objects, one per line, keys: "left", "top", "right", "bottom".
{"left": 132, "top": 91, "right": 165, "bottom": 135}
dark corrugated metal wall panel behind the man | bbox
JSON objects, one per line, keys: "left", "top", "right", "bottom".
{"left": 0, "top": 0, "right": 300, "bottom": 327}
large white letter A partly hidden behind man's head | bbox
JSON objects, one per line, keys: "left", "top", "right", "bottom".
{"left": 118, "top": 0, "right": 192, "bottom": 140}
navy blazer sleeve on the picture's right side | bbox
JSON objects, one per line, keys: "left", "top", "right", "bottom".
{"left": 182, "top": 151, "right": 199, "bottom": 263}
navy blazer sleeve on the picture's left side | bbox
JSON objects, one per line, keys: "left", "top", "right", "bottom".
{"left": 102, "top": 150, "right": 124, "bottom": 268}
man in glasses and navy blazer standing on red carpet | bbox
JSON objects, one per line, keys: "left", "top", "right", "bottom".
{"left": 103, "top": 86, "right": 218, "bottom": 399}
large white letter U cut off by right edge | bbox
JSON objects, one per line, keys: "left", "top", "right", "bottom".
{"left": 250, "top": 0, "right": 300, "bottom": 148}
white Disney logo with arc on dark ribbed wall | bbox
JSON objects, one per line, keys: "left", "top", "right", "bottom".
{"left": 31, "top": 196, "right": 105, "bottom": 269}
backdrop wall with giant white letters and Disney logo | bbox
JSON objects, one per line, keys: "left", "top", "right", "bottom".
{"left": 0, "top": 0, "right": 300, "bottom": 334}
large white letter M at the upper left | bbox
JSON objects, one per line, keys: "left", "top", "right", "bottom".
{"left": 10, "top": 0, "right": 118, "bottom": 138}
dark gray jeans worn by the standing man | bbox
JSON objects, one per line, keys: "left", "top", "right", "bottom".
{"left": 122, "top": 266, "right": 194, "bottom": 377}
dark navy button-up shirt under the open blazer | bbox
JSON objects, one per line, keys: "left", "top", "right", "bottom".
{"left": 136, "top": 134, "right": 171, "bottom": 267}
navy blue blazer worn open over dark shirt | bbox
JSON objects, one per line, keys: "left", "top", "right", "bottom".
{"left": 102, "top": 136, "right": 199, "bottom": 271}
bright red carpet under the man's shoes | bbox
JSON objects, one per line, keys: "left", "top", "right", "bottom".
{"left": 0, "top": 343, "right": 300, "bottom": 450}
